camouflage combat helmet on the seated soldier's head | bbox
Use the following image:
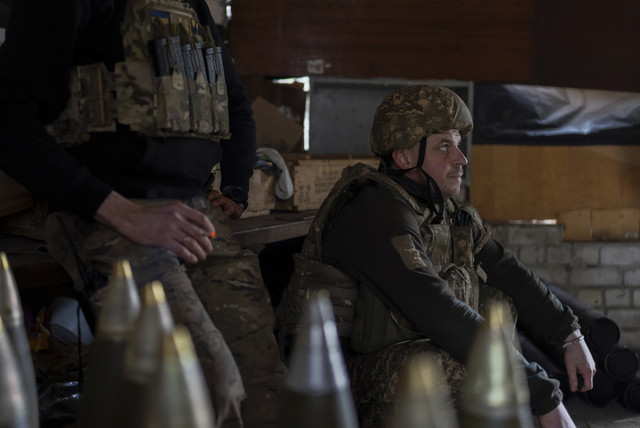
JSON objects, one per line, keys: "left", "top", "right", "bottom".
{"left": 371, "top": 85, "right": 473, "bottom": 156}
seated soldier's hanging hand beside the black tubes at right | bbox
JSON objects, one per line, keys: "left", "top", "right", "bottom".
{"left": 564, "top": 330, "right": 596, "bottom": 392}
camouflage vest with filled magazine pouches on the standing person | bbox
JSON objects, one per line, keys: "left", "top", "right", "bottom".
{"left": 47, "top": 0, "right": 230, "bottom": 146}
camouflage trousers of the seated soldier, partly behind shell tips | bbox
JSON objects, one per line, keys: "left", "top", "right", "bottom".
{"left": 345, "top": 284, "right": 516, "bottom": 428}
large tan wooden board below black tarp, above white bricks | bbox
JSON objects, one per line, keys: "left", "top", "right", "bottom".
{"left": 470, "top": 144, "right": 640, "bottom": 221}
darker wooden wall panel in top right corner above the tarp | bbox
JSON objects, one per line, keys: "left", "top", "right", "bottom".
{"left": 534, "top": 0, "right": 640, "bottom": 92}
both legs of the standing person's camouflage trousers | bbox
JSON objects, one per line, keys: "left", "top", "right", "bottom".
{"left": 45, "top": 200, "right": 286, "bottom": 428}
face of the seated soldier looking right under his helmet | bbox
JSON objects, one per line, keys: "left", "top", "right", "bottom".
{"left": 414, "top": 129, "right": 468, "bottom": 198}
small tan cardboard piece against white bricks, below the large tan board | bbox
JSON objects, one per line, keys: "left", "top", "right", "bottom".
{"left": 557, "top": 207, "right": 640, "bottom": 242}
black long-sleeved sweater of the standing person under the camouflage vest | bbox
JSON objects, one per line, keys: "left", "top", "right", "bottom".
{"left": 0, "top": 0, "right": 256, "bottom": 218}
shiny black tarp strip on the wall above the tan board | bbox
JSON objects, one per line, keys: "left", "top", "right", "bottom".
{"left": 473, "top": 83, "right": 640, "bottom": 145}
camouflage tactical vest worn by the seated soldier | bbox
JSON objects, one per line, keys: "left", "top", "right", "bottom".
{"left": 278, "top": 164, "right": 489, "bottom": 352}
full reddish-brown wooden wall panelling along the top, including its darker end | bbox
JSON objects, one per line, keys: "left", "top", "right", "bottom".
{"left": 229, "top": 0, "right": 640, "bottom": 92}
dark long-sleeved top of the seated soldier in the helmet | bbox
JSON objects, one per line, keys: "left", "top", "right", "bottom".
{"left": 322, "top": 177, "right": 580, "bottom": 415}
